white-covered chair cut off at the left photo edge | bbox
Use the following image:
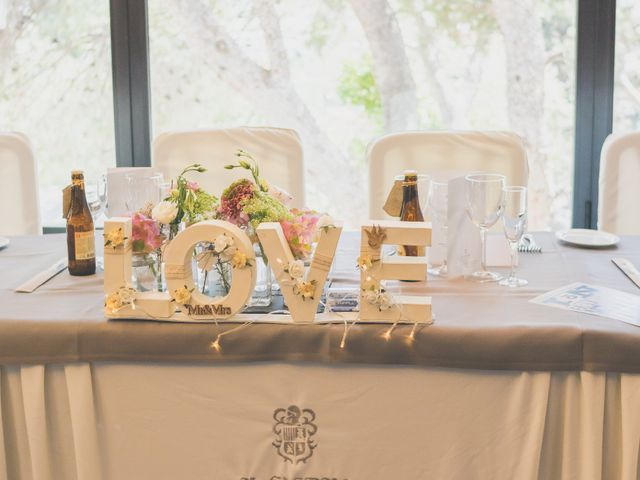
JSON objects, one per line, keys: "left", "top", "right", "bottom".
{"left": 0, "top": 132, "right": 42, "bottom": 235}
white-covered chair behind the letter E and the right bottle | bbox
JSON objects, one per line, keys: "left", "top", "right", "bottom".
{"left": 367, "top": 131, "right": 529, "bottom": 219}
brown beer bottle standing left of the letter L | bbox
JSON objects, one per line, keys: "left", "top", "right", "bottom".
{"left": 67, "top": 170, "right": 96, "bottom": 275}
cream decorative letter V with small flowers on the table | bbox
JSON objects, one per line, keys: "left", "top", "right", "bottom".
{"left": 256, "top": 222, "right": 342, "bottom": 323}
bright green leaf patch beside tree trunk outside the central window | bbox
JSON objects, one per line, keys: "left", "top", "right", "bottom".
{"left": 338, "top": 57, "right": 382, "bottom": 119}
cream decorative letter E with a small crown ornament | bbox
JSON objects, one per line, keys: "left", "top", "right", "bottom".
{"left": 358, "top": 221, "right": 431, "bottom": 323}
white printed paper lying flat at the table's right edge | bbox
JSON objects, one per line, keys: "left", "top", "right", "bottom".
{"left": 530, "top": 283, "right": 640, "bottom": 327}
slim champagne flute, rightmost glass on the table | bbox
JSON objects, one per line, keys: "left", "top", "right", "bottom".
{"left": 500, "top": 187, "right": 529, "bottom": 287}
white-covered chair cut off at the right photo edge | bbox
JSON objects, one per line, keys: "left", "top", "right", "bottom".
{"left": 598, "top": 132, "right": 640, "bottom": 235}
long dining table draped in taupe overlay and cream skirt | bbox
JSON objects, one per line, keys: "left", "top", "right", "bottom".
{"left": 0, "top": 232, "right": 640, "bottom": 480}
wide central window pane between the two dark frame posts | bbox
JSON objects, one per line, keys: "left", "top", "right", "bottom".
{"left": 149, "top": 0, "right": 577, "bottom": 229}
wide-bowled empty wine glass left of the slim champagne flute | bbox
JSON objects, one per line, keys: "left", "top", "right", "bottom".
{"left": 465, "top": 173, "right": 505, "bottom": 282}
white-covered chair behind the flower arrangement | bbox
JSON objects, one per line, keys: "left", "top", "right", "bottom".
{"left": 153, "top": 127, "right": 305, "bottom": 208}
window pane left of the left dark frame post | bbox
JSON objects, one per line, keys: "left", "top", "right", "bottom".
{"left": 0, "top": 0, "right": 116, "bottom": 226}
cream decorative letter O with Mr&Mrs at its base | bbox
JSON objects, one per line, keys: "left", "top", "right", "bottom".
{"left": 164, "top": 220, "right": 256, "bottom": 318}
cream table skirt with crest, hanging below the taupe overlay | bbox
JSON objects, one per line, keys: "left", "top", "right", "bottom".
{"left": 0, "top": 363, "right": 640, "bottom": 480}
